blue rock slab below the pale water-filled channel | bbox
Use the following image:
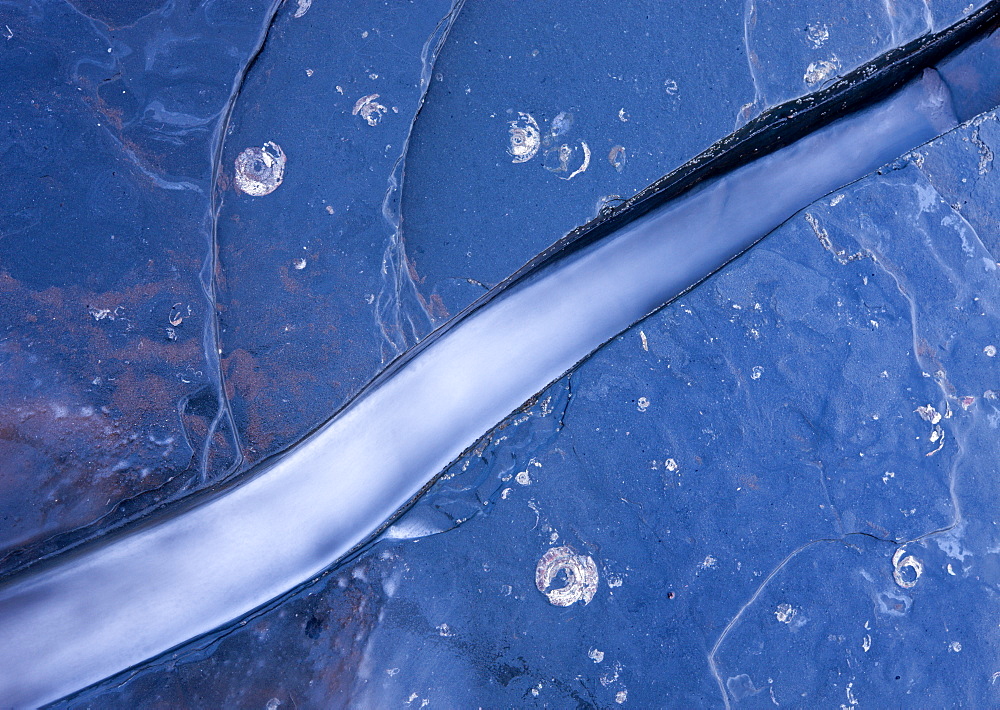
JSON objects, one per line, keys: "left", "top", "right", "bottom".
{"left": 70, "top": 105, "right": 1000, "bottom": 707}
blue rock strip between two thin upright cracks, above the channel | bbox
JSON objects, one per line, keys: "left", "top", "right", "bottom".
{"left": 216, "top": 0, "right": 460, "bottom": 463}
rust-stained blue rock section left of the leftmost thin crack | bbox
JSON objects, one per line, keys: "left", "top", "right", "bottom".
{"left": 0, "top": 2, "right": 272, "bottom": 571}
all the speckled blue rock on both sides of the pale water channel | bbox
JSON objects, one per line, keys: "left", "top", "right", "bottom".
{"left": 0, "top": 0, "right": 1000, "bottom": 709}
